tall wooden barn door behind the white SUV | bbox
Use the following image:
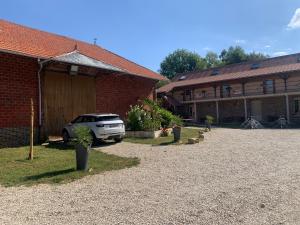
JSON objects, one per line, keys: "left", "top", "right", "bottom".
{"left": 44, "top": 72, "right": 96, "bottom": 136}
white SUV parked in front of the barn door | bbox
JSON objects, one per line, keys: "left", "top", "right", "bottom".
{"left": 62, "top": 114, "right": 125, "bottom": 143}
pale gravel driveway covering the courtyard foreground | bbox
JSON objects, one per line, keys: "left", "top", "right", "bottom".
{"left": 0, "top": 129, "right": 300, "bottom": 225}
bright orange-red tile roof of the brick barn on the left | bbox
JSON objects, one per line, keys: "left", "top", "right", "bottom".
{"left": 0, "top": 20, "right": 166, "bottom": 80}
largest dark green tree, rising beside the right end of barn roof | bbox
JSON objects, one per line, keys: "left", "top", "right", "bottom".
{"left": 159, "top": 49, "right": 206, "bottom": 79}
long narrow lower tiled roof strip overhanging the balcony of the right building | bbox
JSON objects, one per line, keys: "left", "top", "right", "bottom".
{"left": 157, "top": 63, "right": 300, "bottom": 93}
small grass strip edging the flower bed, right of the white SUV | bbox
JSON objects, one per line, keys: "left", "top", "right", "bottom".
{"left": 124, "top": 128, "right": 203, "bottom": 145}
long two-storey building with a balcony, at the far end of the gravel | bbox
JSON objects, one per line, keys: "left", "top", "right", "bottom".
{"left": 157, "top": 53, "right": 300, "bottom": 126}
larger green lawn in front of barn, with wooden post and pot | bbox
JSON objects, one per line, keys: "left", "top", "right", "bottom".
{"left": 0, "top": 144, "right": 139, "bottom": 186}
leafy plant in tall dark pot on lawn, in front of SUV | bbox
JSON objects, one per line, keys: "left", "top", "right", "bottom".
{"left": 74, "top": 126, "right": 93, "bottom": 171}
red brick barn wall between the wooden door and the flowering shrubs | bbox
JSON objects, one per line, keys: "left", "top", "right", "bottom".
{"left": 96, "top": 75, "right": 155, "bottom": 118}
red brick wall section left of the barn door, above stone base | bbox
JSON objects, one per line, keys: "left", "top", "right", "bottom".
{"left": 0, "top": 52, "right": 38, "bottom": 128}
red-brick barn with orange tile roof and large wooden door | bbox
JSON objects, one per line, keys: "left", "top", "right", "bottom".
{"left": 0, "top": 20, "right": 164, "bottom": 147}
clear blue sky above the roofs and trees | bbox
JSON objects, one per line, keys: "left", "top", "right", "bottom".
{"left": 0, "top": 0, "right": 300, "bottom": 71}
